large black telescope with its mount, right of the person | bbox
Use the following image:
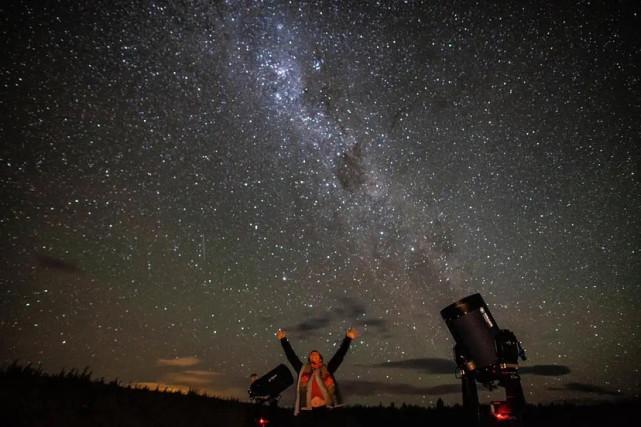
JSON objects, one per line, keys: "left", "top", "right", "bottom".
{"left": 441, "top": 294, "right": 526, "bottom": 426}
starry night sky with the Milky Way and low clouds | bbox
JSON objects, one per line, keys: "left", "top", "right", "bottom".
{"left": 0, "top": 0, "right": 641, "bottom": 406}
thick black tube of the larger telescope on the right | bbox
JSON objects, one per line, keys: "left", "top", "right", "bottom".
{"left": 441, "top": 294, "right": 500, "bottom": 370}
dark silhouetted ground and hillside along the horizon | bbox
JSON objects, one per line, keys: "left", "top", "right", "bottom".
{"left": 0, "top": 363, "right": 639, "bottom": 427}
